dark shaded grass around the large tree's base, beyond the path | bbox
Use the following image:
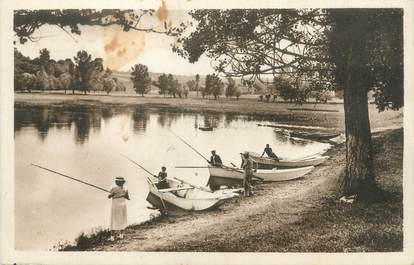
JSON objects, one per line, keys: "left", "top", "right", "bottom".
{"left": 163, "top": 129, "right": 403, "bottom": 252}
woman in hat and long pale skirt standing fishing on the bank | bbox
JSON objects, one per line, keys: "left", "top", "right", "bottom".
{"left": 108, "top": 177, "right": 129, "bottom": 241}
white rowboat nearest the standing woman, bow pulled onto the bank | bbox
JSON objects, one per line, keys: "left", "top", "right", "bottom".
{"left": 147, "top": 175, "right": 239, "bottom": 211}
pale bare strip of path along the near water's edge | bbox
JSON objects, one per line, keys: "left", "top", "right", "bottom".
{"left": 88, "top": 143, "right": 344, "bottom": 251}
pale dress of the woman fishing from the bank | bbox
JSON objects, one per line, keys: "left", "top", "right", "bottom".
{"left": 110, "top": 186, "right": 128, "bottom": 230}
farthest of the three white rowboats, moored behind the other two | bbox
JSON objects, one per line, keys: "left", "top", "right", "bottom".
{"left": 244, "top": 152, "right": 329, "bottom": 168}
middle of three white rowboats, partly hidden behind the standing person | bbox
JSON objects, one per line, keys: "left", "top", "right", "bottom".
{"left": 208, "top": 166, "right": 314, "bottom": 189}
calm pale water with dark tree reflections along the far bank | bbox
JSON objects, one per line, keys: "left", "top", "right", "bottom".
{"left": 15, "top": 106, "right": 327, "bottom": 250}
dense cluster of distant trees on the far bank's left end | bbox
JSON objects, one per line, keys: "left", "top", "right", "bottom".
{"left": 14, "top": 49, "right": 126, "bottom": 93}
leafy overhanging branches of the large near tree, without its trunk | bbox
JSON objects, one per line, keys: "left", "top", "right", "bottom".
{"left": 173, "top": 9, "right": 403, "bottom": 110}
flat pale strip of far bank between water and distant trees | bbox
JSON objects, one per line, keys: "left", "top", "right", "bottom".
{"left": 14, "top": 93, "right": 403, "bottom": 131}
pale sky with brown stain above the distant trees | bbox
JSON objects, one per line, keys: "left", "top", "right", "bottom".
{"left": 16, "top": 10, "right": 213, "bottom": 75}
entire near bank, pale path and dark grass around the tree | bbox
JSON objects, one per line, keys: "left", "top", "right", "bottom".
{"left": 59, "top": 129, "right": 403, "bottom": 252}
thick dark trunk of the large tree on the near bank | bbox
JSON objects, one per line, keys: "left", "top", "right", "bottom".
{"left": 341, "top": 36, "right": 377, "bottom": 200}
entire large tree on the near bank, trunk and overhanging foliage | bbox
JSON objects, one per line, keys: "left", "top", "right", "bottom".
{"left": 174, "top": 9, "right": 403, "bottom": 199}
